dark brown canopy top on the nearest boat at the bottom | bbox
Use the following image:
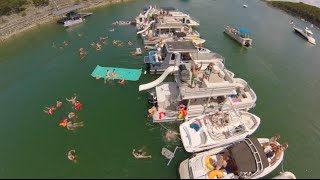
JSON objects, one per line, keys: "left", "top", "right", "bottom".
{"left": 231, "top": 137, "right": 269, "bottom": 172}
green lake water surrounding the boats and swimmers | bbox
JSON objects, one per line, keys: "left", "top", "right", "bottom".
{"left": 0, "top": 0, "right": 320, "bottom": 178}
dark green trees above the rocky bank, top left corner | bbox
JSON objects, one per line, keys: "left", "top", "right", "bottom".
{"left": 0, "top": 0, "right": 49, "bottom": 16}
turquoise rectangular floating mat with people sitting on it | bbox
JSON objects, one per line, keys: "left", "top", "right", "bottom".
{"left": 91, "top": 65, "right": 142, "bottom": 81}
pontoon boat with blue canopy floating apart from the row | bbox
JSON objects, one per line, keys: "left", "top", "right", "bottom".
{"left": 224, "top": 26, "right": 252, "bottom": 47}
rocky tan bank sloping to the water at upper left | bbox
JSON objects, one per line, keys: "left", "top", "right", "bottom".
{"left": 0, "top": 0, "right": 131, "bottom": 42}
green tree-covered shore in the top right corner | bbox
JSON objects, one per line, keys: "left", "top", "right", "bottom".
{"left": 267, "top": 1, "right": 320, "bottom": 25}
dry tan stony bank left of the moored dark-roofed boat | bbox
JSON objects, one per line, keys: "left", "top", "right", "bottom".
{"left": 0, "top": 0, "right": 134, "bottom": 41}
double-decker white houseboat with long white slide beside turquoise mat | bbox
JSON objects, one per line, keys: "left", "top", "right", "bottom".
{"left": 139, "top": 47, "right": 257, "bottom": 122}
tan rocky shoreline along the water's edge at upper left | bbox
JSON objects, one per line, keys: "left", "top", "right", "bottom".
{"left": 0, "top": 0, "right": 132, "bottom": 42}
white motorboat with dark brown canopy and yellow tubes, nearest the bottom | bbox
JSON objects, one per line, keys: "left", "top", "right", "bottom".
{"left": 179, "top": 137, "right": 284, "bottom": 179}
